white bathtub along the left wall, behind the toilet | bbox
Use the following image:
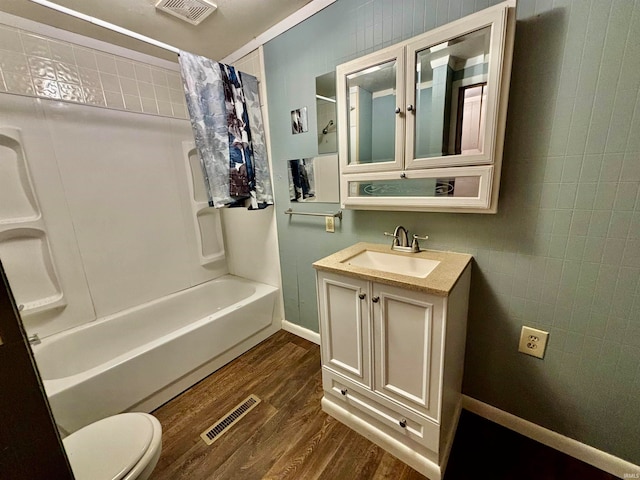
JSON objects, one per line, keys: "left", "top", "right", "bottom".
{"left": 33, "top": 275, "right": 278, "bottom": 434}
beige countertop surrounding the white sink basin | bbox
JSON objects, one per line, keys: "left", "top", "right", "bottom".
{"left": 313, "top": 242, "right": 473, "bottom": 297}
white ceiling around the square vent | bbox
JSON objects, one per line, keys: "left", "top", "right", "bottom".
{"left": 0, "top": 0, "right": 311, "bottom": 60}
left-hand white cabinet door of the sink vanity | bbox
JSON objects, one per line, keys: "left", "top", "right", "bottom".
{"left": 317, "top": 272, "right": 371, "bottom": 388}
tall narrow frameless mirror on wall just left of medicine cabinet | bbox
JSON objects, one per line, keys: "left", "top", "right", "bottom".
{"left": 316, "top": 71, "right": 338, "bottom": 154}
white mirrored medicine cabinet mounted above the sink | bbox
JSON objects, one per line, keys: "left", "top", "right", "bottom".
{"left": 336, "top": 0, "right": 515, "bottom": 213}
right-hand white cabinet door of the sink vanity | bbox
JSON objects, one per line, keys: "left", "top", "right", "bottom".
{"left": 372, "top": 283, "right": 445, "bottom": 422}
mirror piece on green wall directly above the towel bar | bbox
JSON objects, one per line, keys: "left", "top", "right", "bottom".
{"left": 288, "top": 155, "right": 340, "bottom": 203}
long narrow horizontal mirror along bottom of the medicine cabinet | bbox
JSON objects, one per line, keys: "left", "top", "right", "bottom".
{"left": 349, "top": 176, "right": 480, "bottom": 198}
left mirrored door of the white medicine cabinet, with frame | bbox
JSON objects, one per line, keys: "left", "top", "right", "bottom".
{"left": 337, "top": 48, "right": 404, "bottom": 172}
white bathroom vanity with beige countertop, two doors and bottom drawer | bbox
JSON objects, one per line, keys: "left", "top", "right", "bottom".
{"left": 313, "top": 243, "right": 472, "bottom": 480}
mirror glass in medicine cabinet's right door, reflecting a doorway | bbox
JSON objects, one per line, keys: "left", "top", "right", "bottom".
{"left": 415, "top": 27, "right": 491, "bottom": 158}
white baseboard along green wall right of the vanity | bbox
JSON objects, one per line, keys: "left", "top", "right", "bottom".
{"left": 462, "top": 395, "right": 640, "bottom": 478}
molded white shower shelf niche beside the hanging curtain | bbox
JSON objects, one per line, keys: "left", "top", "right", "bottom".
{"left": 182, "top": 141, "right": 225, "bottom": 266}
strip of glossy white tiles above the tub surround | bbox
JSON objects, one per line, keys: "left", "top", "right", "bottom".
{"left": 0, "top": 24, "right": 187, "bottom": 118}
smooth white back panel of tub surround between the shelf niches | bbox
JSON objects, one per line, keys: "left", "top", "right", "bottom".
{"left": 0, "top": 94, "right": 228, "bottom": 338}
